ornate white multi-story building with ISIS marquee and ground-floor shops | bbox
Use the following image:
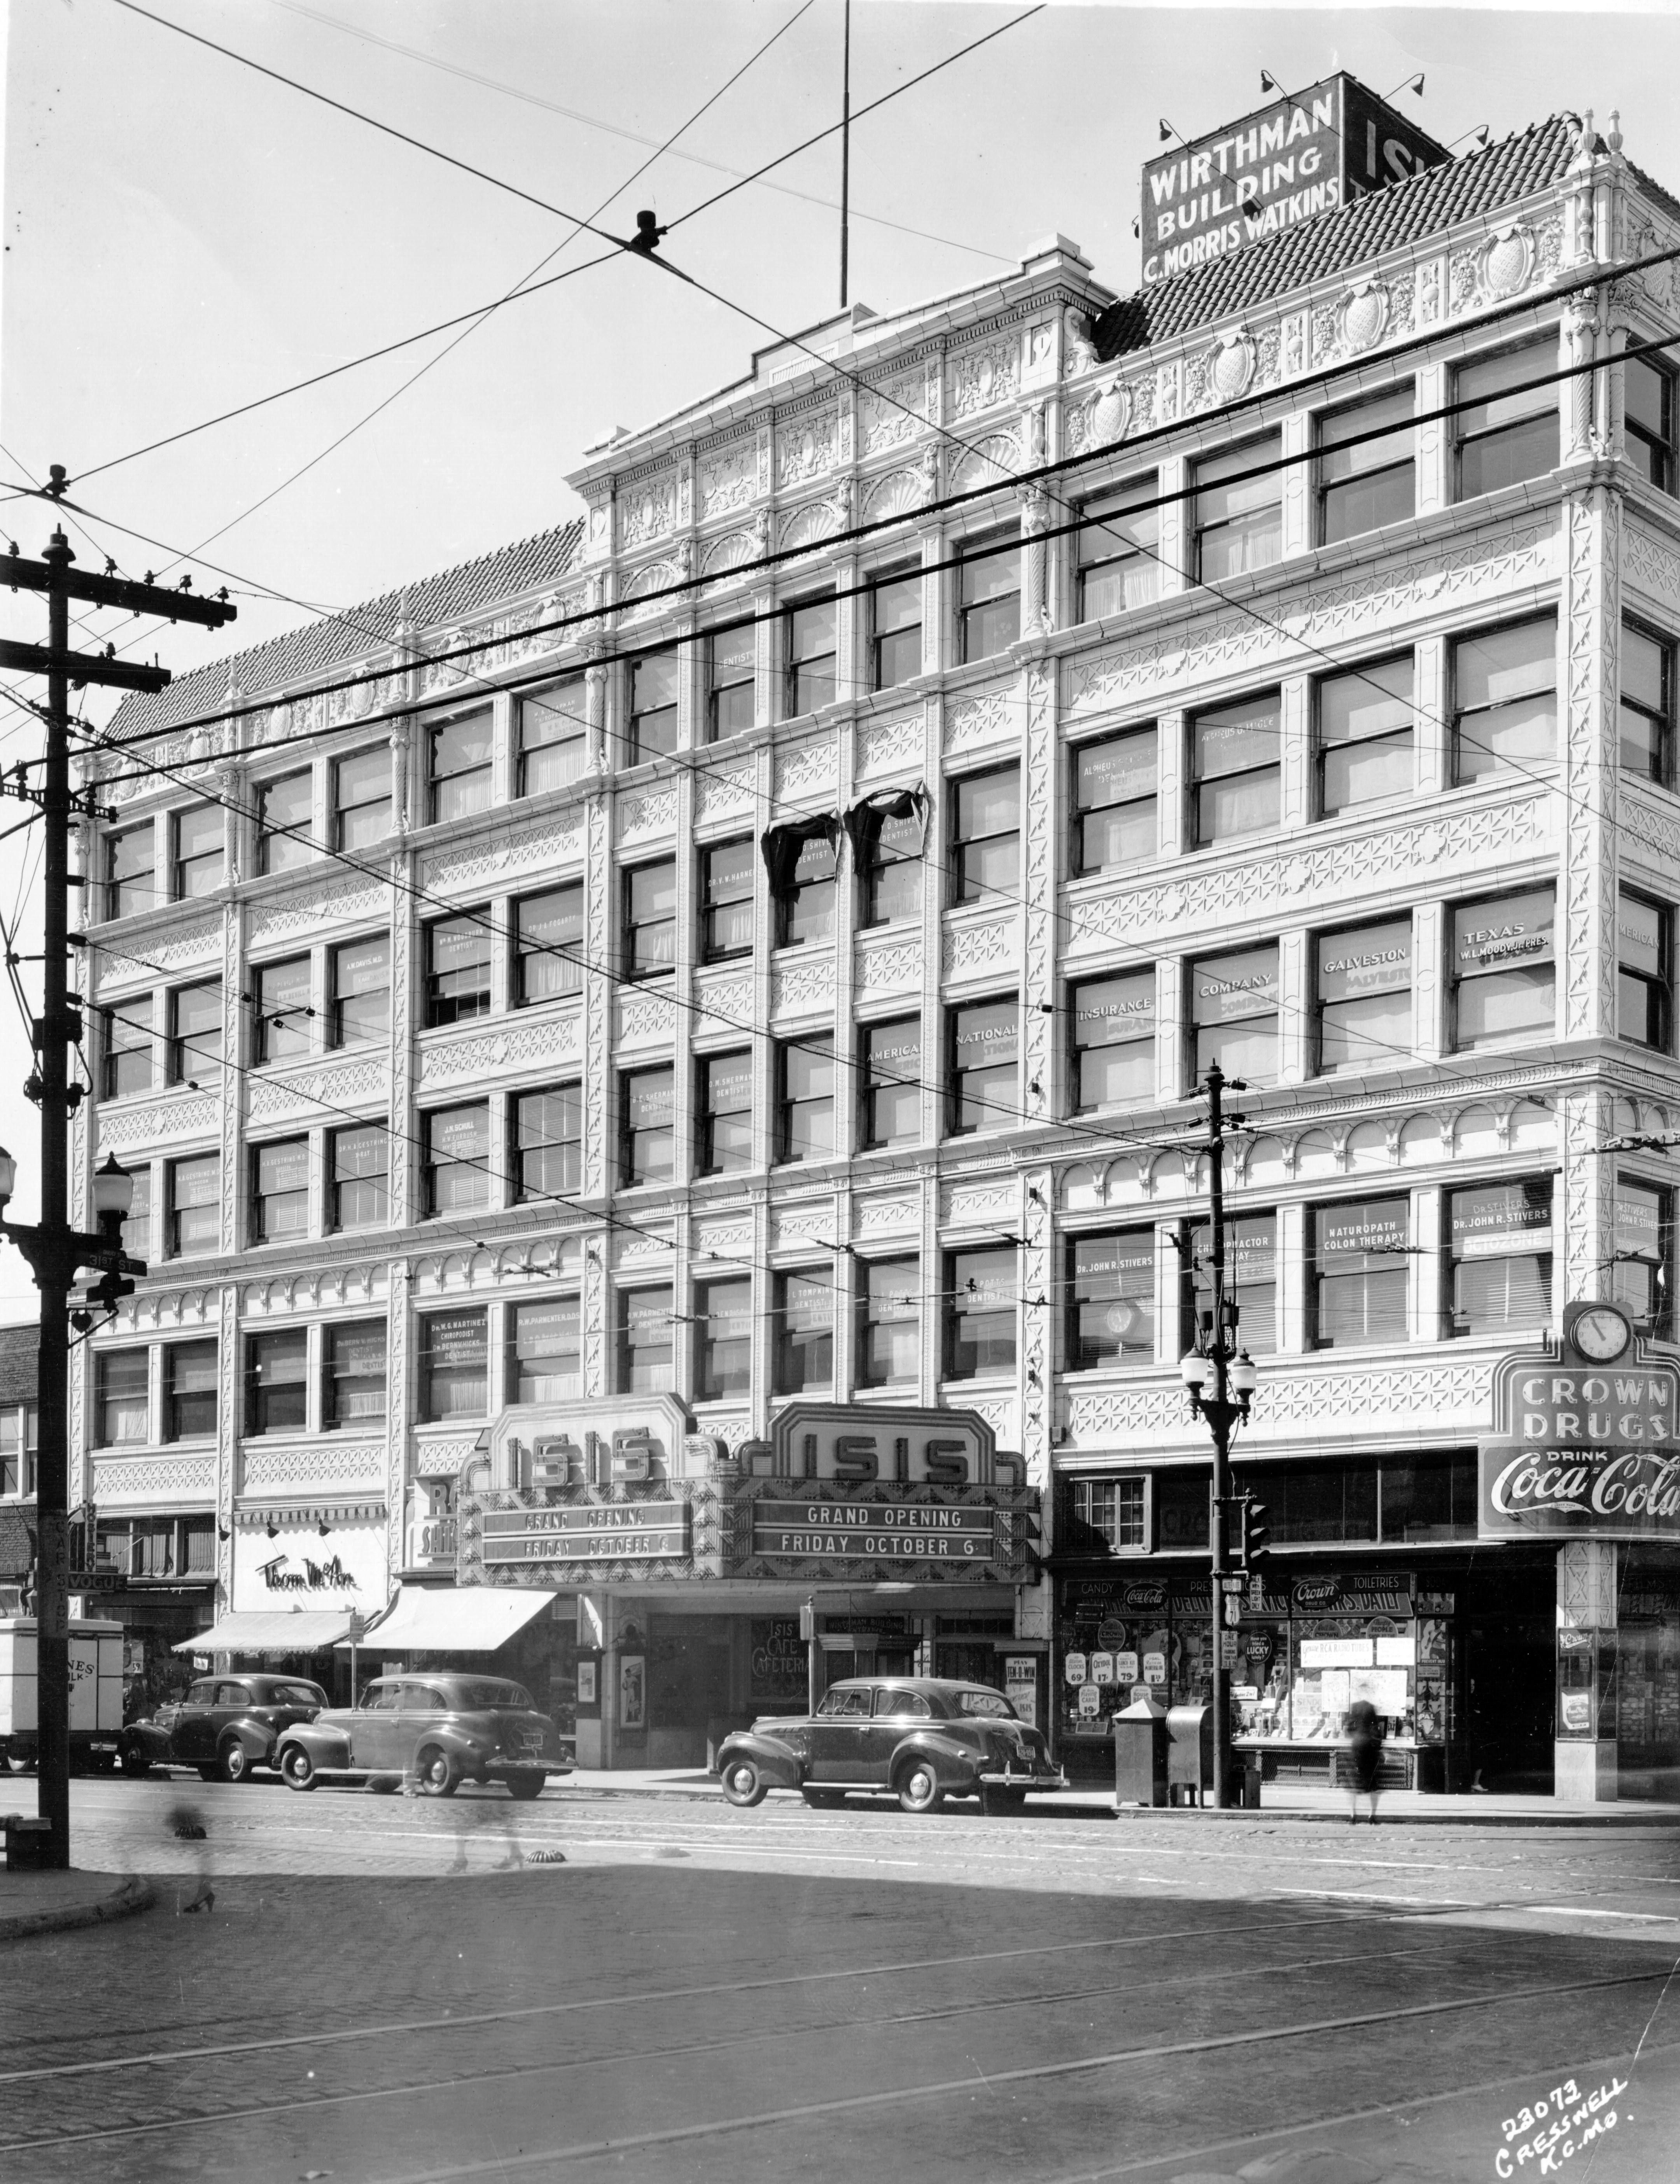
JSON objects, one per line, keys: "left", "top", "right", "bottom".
{"left": 74, "top": 85, "right": 1680, "bottom": 1793}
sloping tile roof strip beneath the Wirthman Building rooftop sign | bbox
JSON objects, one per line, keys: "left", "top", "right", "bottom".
{"left": 1094, "top": 114, "right": 1577, "bottom": 360}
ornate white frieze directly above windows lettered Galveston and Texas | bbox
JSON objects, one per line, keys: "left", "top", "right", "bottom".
{"left": 1068, "top": 795, "right": 1556, "bottom": 950}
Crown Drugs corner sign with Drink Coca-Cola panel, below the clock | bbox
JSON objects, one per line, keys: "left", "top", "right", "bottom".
{"left": 1477, "top": 1358, "right": 1680, "bottom": 1540}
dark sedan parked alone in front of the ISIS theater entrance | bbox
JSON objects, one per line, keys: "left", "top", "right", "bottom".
{"left": 717, "top": 1675, "right": 1068, "bottom": 1813}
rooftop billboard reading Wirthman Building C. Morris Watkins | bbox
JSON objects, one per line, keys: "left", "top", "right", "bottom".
{"left": 1143, "top": 74, "right": 1451, "bottom": 288}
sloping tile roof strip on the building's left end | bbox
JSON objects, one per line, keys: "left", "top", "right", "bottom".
{"left": 109, "top": 520, "right": 583, "bottom": 738}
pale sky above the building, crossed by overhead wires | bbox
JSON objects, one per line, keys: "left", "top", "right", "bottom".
{"left": 0, "top": 0, "right": 1680, "bottom": 1317}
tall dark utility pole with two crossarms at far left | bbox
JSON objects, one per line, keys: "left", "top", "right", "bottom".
{"left": 0, "top": 463, "right": 236, "bottom": 1869}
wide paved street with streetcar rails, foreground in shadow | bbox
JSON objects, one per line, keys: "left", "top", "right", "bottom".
{"left": 0, "top": 1778, "right": 1680, "bottom": 2184}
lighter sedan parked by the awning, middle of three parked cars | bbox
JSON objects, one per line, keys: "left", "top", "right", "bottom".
{"left": 277, "top": 1671, "right": 572, "bottom": 1797}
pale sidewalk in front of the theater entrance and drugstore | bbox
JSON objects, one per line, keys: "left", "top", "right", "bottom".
{"left": 551, "top": 1767, "right": 1680, "bottom": 1828}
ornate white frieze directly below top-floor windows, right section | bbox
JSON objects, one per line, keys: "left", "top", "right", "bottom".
{"left": 1062, "top": 518, "right": 1560, "bottom": 721}
